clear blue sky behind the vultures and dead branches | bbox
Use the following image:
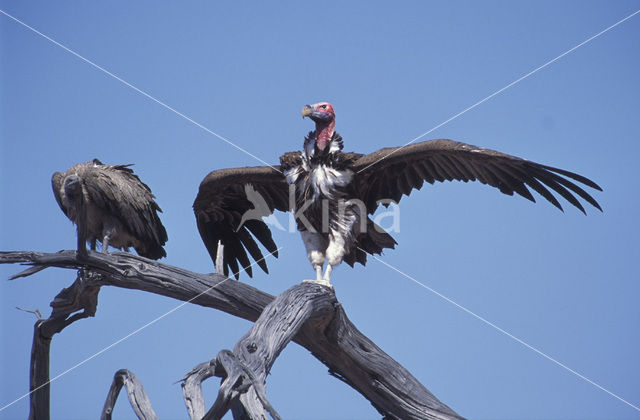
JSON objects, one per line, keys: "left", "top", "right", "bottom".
{"left": 0, "top": 0, "right": 640, "bottom": 420}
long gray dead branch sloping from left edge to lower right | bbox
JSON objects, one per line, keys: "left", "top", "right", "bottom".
{"left": 0, "top": 251, "right": 460, "bottom": 419}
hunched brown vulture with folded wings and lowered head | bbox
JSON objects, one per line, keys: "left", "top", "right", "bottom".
{"left": 51, "top": 159, "right": 168, "bottom": 260}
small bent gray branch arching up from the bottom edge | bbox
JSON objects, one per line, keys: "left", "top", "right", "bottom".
{"left": 100, "top": 369, "right": 158, "bottom": 420}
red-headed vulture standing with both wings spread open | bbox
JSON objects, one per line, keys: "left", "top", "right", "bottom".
{"left": 193, "top": 102, "right": 602, "bottom": 285}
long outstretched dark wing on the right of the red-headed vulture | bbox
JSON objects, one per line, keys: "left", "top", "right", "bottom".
{"left": 353, "top": 140, "right": 602, "bottom": 213}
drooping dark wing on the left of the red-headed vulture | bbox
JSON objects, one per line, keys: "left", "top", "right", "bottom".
{"left": 193, "top": 166, "right": 289, "bottom": 279}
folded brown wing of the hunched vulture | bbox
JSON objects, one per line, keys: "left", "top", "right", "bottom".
{"left": 81, "top": 159, "right": 168, "bottom": 259}
